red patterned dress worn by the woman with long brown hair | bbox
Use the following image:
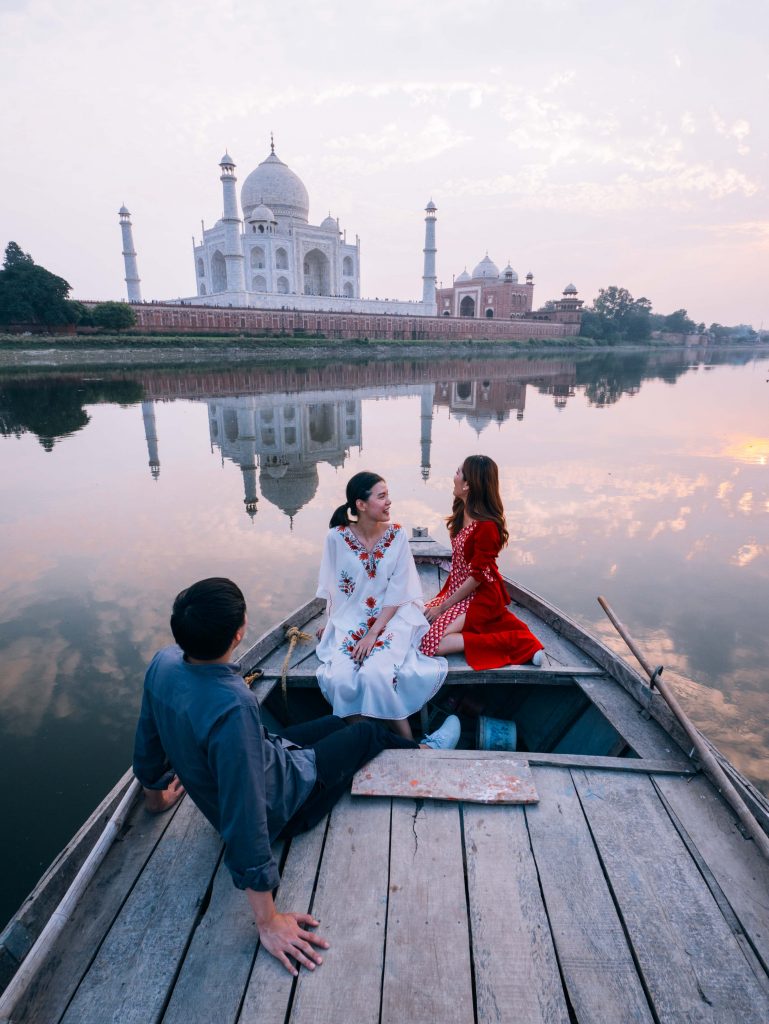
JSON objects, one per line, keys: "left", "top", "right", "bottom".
{"left": 421, "top": 519, "right": 543, "bottom": 670}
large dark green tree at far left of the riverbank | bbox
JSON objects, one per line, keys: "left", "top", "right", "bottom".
{"left": 0, "top": 242, "right": 75, "bottom": 327}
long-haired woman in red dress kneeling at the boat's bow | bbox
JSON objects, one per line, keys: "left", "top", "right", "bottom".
{"left": 421, "top": 455, "right": 543, "bottom": 670}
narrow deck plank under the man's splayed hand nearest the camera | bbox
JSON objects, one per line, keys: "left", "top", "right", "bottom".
{"left": 238, "top": 818, "right": 331, "bottom": 1024}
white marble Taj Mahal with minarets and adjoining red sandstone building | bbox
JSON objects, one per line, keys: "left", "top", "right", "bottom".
{"left": 119, "top": 136, "right": 583, "bottom": 334}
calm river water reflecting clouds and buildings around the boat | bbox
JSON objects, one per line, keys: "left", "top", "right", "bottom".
{"left": 0, "top": 351, "right": 769, "bottom": 924}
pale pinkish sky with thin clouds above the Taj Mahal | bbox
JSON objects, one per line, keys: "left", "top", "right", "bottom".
{"left": 0, "top": 0, "right": 769, "bottom": 328}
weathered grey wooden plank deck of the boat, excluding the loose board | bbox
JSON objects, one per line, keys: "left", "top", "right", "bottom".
{"left": 14, "top": 752, "right": 769, "bottom": 1024}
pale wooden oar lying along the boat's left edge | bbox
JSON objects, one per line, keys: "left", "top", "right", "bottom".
{"left": 0, "top": 778, "right": 141, "bottom": 1024}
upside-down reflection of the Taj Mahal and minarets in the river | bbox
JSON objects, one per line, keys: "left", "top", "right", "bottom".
{"left": 141, "top": 367, "right": 574, "bottom": 522}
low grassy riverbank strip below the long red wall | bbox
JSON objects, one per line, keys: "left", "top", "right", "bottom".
{"left": 0, "top": 334, "right": 769, "bottom": 371}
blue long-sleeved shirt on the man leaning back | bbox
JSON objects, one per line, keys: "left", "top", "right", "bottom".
{"left": 133, "top": 646, "right": 316, "bottom": 892}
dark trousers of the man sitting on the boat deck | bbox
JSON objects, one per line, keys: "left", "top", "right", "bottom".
{"left": 281, "top": 715, "right": 419, "bottom": 839}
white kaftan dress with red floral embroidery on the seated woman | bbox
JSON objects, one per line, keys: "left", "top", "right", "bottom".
{"left": 317, "top": 523, "right": 448, "bottom": 720}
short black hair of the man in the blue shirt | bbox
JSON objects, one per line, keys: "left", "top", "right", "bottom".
{"left": 171, "top": 577, "right": 246, "bottom": 662}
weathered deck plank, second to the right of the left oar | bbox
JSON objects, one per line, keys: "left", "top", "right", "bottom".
{"left": 62, "top": 800, "right": 221, "bottom": 1024}
